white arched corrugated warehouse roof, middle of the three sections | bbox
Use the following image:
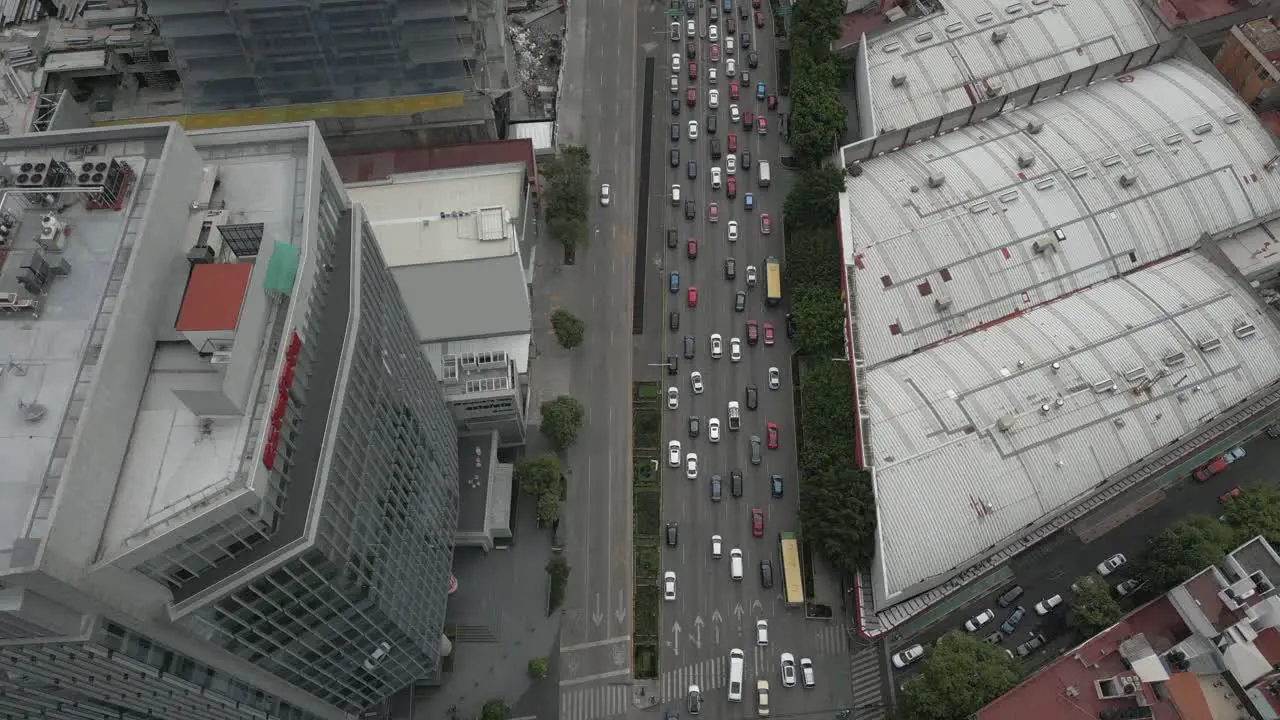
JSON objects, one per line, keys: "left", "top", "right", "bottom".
{"left": 841, "top": 58, "right": 1280, "bottom": 366}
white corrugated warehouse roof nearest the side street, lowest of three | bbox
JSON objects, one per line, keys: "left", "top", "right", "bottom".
{"left": 860, "top": 255, "right": 1280, "bottom": 607}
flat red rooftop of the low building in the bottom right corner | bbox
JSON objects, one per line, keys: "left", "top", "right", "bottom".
{"left": 977, "top": 597, "right": 1190, "bottom": 720}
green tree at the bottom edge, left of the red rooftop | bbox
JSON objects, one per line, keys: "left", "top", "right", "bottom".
{"left": 902, "top": 632, "right": 1023, "bottom": 720}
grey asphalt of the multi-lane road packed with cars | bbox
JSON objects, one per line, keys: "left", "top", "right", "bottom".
{"left": 641, "top": 0, "right": 850, "bottom": 717}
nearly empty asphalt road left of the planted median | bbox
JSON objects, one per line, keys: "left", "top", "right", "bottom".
{"left": 559, "top": 0, "right": 641, "bottom": 702}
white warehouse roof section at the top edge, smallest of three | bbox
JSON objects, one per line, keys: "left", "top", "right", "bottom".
{"left": 859, "top": 0, "right": 1156, "bottom": 135}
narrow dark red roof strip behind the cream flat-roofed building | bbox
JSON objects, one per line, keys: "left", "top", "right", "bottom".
{"left": 333, "top": 138, "right": 538, "bottom": 182}
